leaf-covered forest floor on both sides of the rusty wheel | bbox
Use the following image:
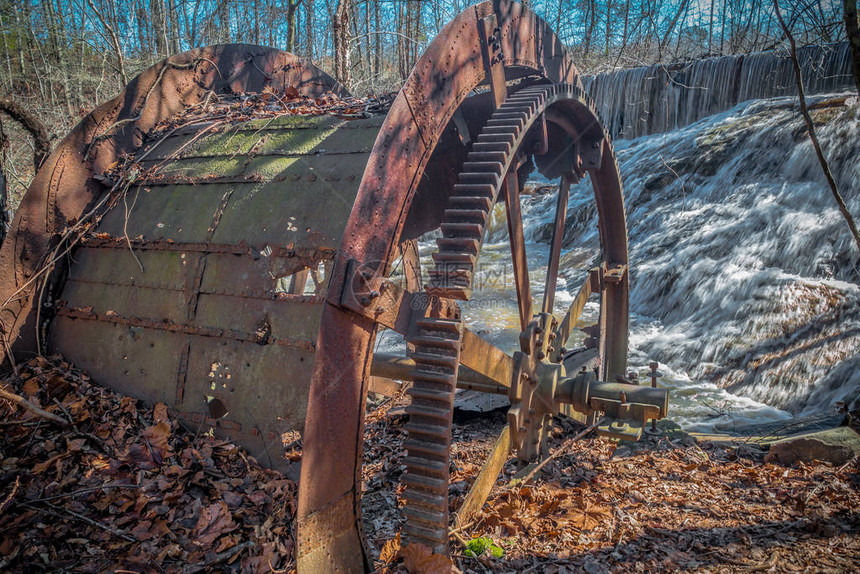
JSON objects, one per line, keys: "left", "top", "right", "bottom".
{"left": 0, "top": 358, "right": 860, "bottom": 574}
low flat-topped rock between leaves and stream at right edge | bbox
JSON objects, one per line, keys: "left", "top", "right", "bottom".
{"left": 765, "top": 426, "right": 860, "bottom": 465}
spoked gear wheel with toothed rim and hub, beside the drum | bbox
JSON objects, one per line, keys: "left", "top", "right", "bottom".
{"left": 402, "top": 84, "right": 627, "bottom": 553}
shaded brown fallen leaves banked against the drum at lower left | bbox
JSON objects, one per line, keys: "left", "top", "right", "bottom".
{"left": 0, "top": 358, "right": 296, "bottom": 573}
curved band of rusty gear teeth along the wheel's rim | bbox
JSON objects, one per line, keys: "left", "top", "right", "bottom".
{"left": 402, "top": 84, "right": 608, "bottom": 552}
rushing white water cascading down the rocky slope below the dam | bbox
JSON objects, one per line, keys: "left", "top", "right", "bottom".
{"left": 388, "top": 91, "right": 860, "bottom": 431}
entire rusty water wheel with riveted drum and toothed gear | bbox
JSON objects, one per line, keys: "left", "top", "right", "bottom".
{"left": 0, "top": 0, "right": 627, "bottom": 572}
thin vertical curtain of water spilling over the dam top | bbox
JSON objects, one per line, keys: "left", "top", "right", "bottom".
{"left": 583, "top": 42, "right": 854, "bottom": 139}
